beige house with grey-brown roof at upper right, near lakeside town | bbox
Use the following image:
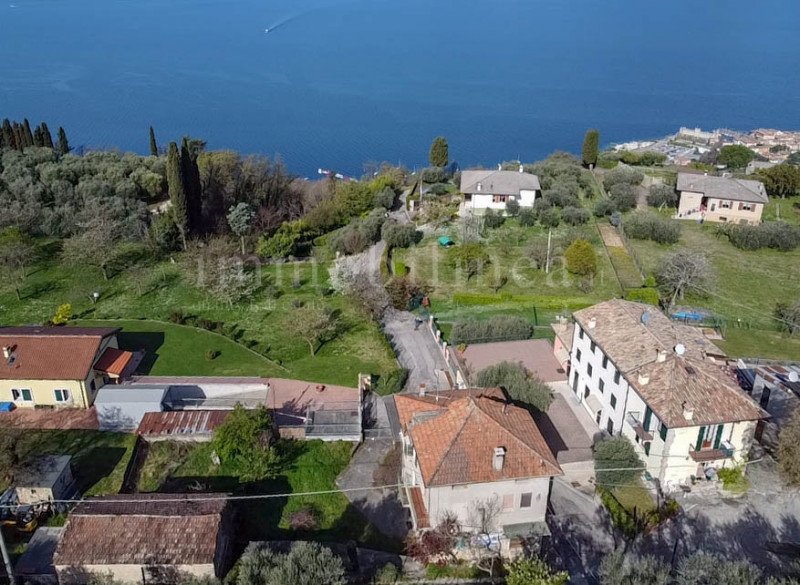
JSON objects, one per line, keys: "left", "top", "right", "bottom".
{"left": 675, "top": 173, "right": 769, "bottom": 224}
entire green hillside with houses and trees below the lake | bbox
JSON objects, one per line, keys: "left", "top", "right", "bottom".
{"left": 0, "top": 126, "right": 800, "bottom": 585}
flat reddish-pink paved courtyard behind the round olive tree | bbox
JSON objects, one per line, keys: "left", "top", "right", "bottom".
{"left": 462, "top": 339, "right": 567, "bottom": 382}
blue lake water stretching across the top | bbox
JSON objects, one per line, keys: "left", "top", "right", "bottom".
{"left": 0, "top": 0, "right": 800, "bottom": 175}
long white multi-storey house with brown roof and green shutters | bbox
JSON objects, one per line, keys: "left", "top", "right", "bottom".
{"left": 569, "top": 299, "right": 768, "bottom": 491}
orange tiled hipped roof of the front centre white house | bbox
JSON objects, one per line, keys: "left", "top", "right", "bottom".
{"left": 395, "top": 389, "right": 561, "bottom": 486}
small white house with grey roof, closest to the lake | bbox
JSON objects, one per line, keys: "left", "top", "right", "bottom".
{"left": 459, "top": 165, "right": 541, "bottom": 215}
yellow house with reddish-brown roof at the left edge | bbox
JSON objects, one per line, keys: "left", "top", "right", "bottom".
{"left": 0, "top": 327, "right": 142, "bottom": 408}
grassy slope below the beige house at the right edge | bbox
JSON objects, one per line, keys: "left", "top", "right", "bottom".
{"left": 630, "top": 222, "right": 800, "bottom": 359}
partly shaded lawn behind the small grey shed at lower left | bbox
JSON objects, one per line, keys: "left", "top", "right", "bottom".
{"left": 0, "top": 430, "right": 136, "bottom": 496}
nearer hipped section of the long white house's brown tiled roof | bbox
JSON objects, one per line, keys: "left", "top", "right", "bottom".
{"left": 629, "top": 354, "right": 769, "bottom": 428}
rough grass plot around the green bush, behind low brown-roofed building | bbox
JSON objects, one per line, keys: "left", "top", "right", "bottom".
{"left": 139, "top": 441, "right": 400, "bottom": 551}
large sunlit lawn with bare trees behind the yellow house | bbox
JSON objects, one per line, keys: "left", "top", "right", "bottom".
{"left": 0, "top": 242, "right": 397, "bottom": 386}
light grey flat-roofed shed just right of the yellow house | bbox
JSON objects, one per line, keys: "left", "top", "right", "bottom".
{"left": 94, "top": 384, "right": 169, "bottom": 431}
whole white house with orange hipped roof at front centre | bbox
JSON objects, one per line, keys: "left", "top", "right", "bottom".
{"left": 394, "top": 388, "right": 562, "bottom": 550}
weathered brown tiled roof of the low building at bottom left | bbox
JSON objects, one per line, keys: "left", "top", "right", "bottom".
{"left": 54, "top": 494, "right": 226, "bottom": 566}
